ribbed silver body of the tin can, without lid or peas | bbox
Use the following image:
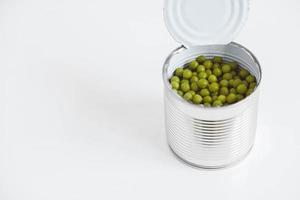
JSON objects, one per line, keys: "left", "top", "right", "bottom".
{"left": 163, "top": 43, "right": 261, "bottom": 169}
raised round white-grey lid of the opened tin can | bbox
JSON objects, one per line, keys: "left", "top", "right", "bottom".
{"left": 164, "top": 0, "right": 249, "bottom": 47}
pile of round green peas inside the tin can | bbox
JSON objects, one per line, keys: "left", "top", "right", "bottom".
{"left": 169, "top": 56, "right": 257, "bottom": 107}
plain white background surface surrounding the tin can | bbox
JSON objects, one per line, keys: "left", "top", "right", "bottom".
{"left": 0, "top": 0, "right": 300, "bottom": 200}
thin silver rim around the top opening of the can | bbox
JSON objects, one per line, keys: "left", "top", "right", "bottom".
{"left": 162, "top": 42, "right": 262, "bottom": 110}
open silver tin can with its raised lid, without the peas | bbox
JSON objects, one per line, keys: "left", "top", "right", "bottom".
{"left": 163, "top": 0, "right": 262, "bottom": 169}
